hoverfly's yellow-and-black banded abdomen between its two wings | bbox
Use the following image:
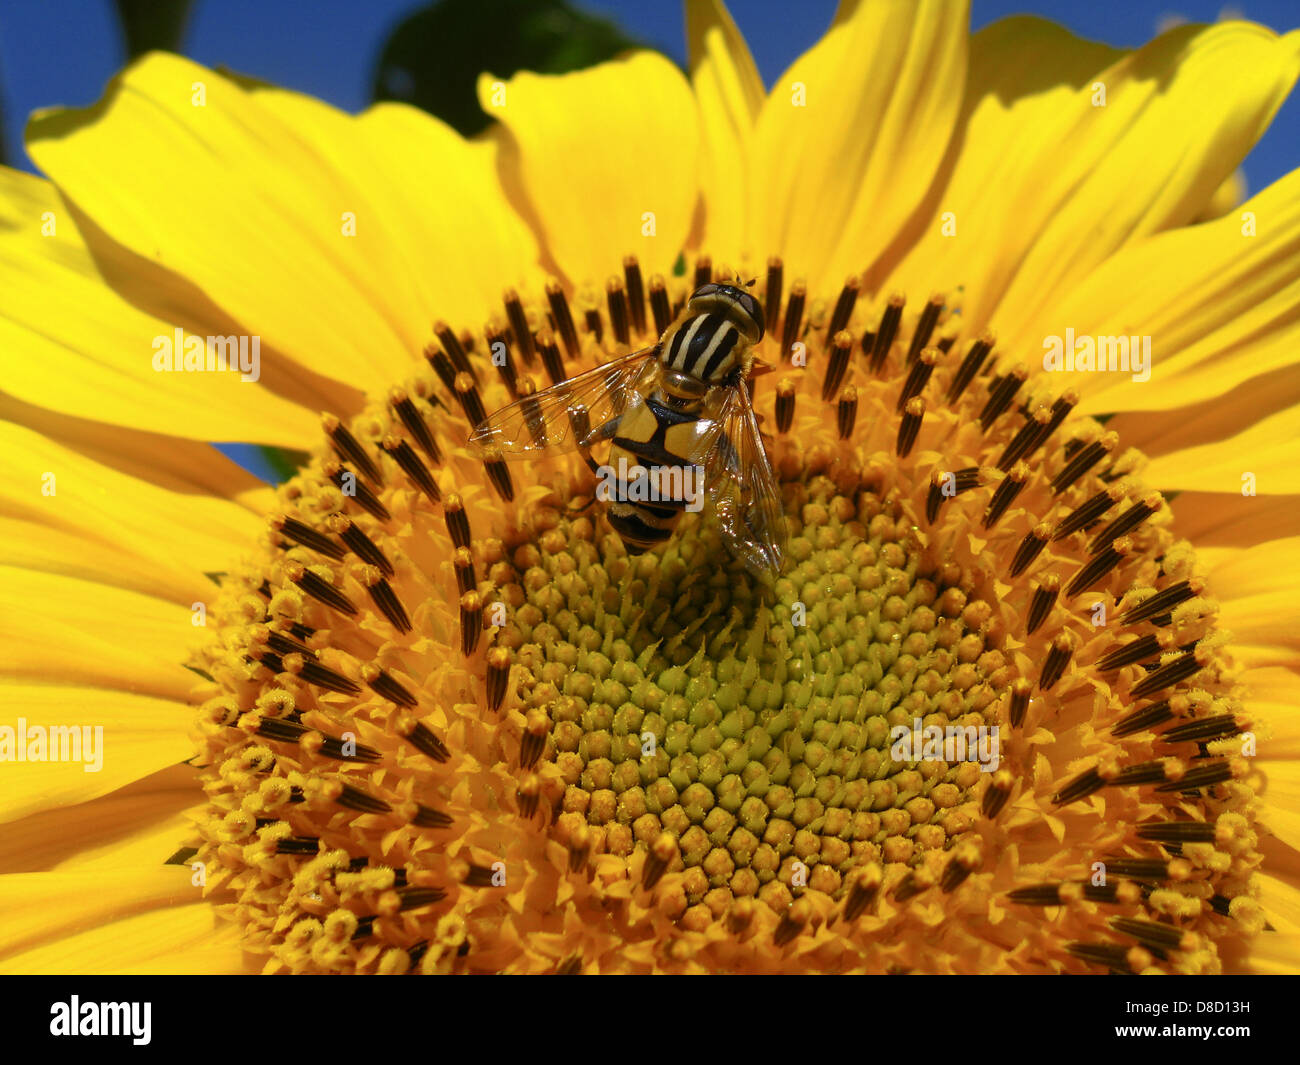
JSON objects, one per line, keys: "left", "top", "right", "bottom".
{"left": 606, "top": 397, "right": 699, "bottom": 554}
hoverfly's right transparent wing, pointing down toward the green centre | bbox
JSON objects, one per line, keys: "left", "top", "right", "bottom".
{"left": 696, "top": 384, "right": 785, "bottom": 576}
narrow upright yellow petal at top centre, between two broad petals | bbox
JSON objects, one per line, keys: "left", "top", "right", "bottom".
{"left": 686, "top": 0, "right": 766, "bottom": 267}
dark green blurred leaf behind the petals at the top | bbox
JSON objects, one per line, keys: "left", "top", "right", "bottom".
{"left": 373, "top": 0, "right": 644, "bottom": 137}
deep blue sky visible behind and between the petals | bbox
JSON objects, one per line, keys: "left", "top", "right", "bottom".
{"left": 0, "top": 0, "right": 1300, "bottom": 481}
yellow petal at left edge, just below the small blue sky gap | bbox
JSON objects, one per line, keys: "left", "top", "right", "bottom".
{"left": 0, "top": 421, "right": 265, "bottom": 606}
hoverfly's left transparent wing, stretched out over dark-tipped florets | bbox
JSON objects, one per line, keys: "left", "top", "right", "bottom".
{"left": 469, "top": 346, "right": 659, "bottom": 459}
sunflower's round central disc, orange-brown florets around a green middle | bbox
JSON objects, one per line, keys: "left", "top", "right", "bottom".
{"left": 194, "top": 260, "right": 1262, "bottom": 973}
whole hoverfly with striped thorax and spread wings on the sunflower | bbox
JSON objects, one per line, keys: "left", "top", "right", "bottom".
{"left": 469, "top": 282, "right": 785, "bottom": 573}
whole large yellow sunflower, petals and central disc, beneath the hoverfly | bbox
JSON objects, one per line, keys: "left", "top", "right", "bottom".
{"left": 0, "top": 3, "right": 1300, "bottom": 973}
